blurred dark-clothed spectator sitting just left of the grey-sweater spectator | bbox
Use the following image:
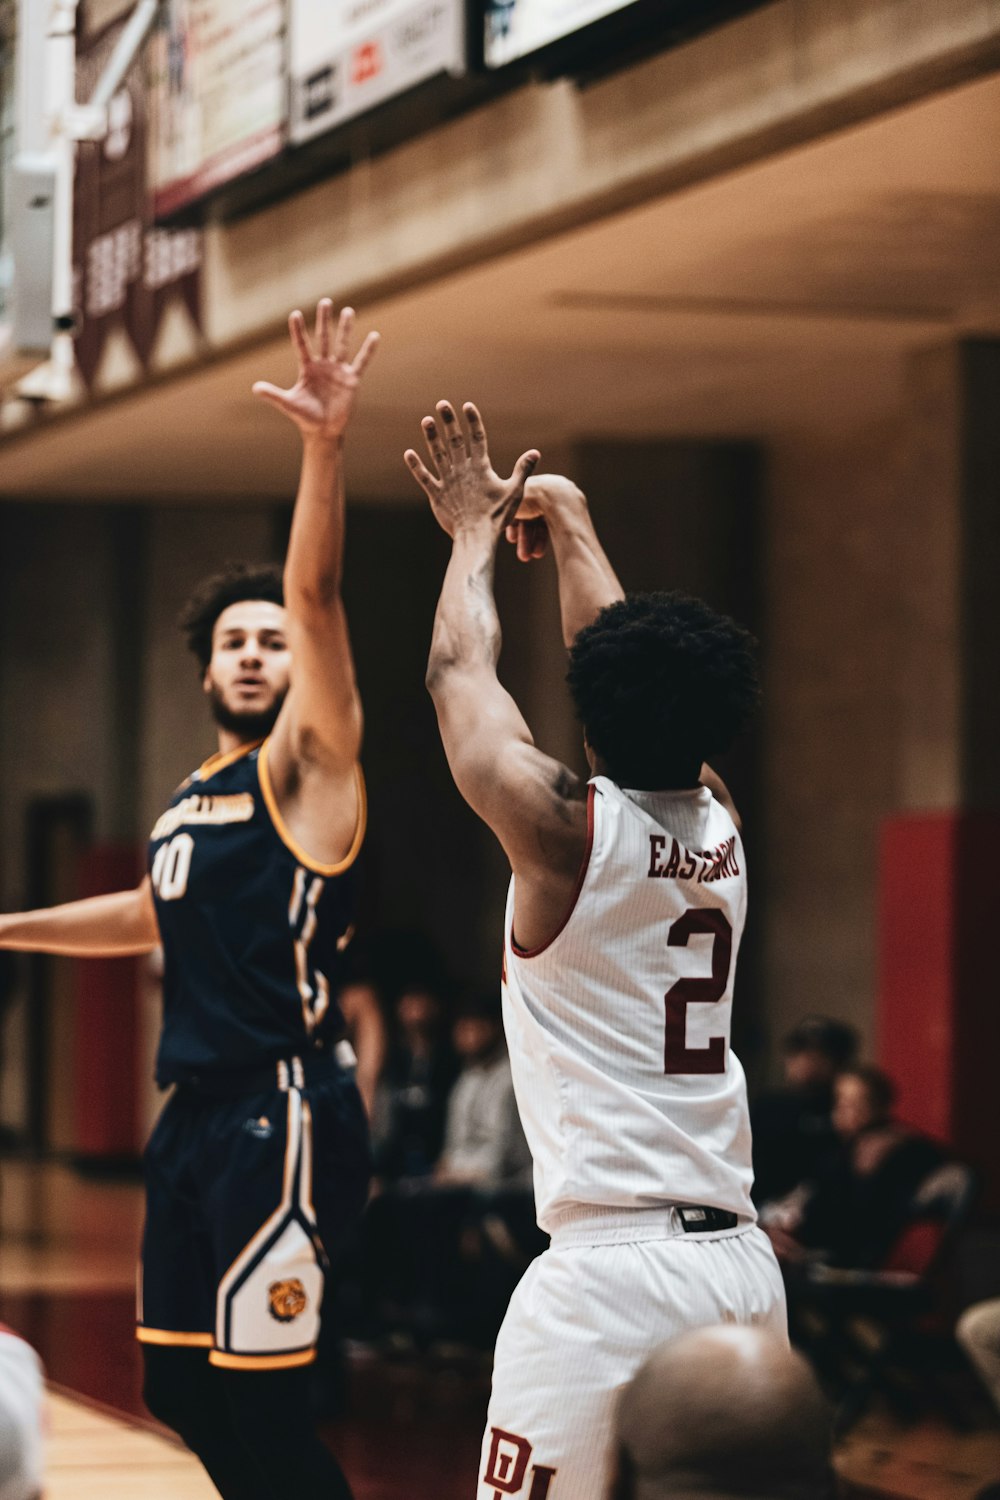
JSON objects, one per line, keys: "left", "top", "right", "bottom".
{"left": 375, "top": 984, "right": 457, "bottom": 1182}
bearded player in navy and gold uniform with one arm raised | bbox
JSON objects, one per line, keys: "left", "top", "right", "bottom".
{"left": 0, "top": 300, "right": 378, "bottom": 1500}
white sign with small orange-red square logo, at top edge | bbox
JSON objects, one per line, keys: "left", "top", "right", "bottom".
{"left": 289, "top": 0, "right": 465, "bottom": 143}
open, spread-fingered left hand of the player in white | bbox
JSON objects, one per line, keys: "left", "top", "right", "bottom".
{"left": 403, "top": 401, "right": 538, "bottom": 537}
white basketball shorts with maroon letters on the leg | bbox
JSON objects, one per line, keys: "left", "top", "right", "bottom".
{"left": 477, "top": 1215, "right": 787, "bottom": 1500}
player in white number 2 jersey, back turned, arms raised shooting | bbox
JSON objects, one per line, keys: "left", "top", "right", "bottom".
{"left": 406, "top": 402, "right": 786, "bottom": 1500}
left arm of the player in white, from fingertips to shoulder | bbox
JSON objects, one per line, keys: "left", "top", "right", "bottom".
{"left": 406, "top": 402, "right": 586, "bottom": 881}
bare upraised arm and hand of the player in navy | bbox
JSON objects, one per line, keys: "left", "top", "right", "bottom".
{"left": 253, "top": 299, "right": 378, "bottom": 783}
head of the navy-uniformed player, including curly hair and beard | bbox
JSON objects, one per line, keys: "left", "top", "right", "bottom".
{"left": 180, "top": 563, "right": 291, "bottom": 744}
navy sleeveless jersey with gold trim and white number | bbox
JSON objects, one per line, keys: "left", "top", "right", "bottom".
{"left": 148, "top": 741, "right": 364, "bottom": 1086}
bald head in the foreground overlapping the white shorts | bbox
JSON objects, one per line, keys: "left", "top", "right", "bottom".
{"left": 609, "top": 1325, "right": 835, "bottom": 1500}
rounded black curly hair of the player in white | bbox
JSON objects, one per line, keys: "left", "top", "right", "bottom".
{"left": 567, "top": 593, "right": 760, "bottom": 791}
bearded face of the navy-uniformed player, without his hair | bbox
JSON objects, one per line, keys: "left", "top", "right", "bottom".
{"left": 204, "top": 600, "right": 291, "bottom": 743}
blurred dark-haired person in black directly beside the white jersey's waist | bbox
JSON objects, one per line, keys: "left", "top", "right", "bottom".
{"left": 750, "top": 1016, "right": 858, "bottom": 1208}
